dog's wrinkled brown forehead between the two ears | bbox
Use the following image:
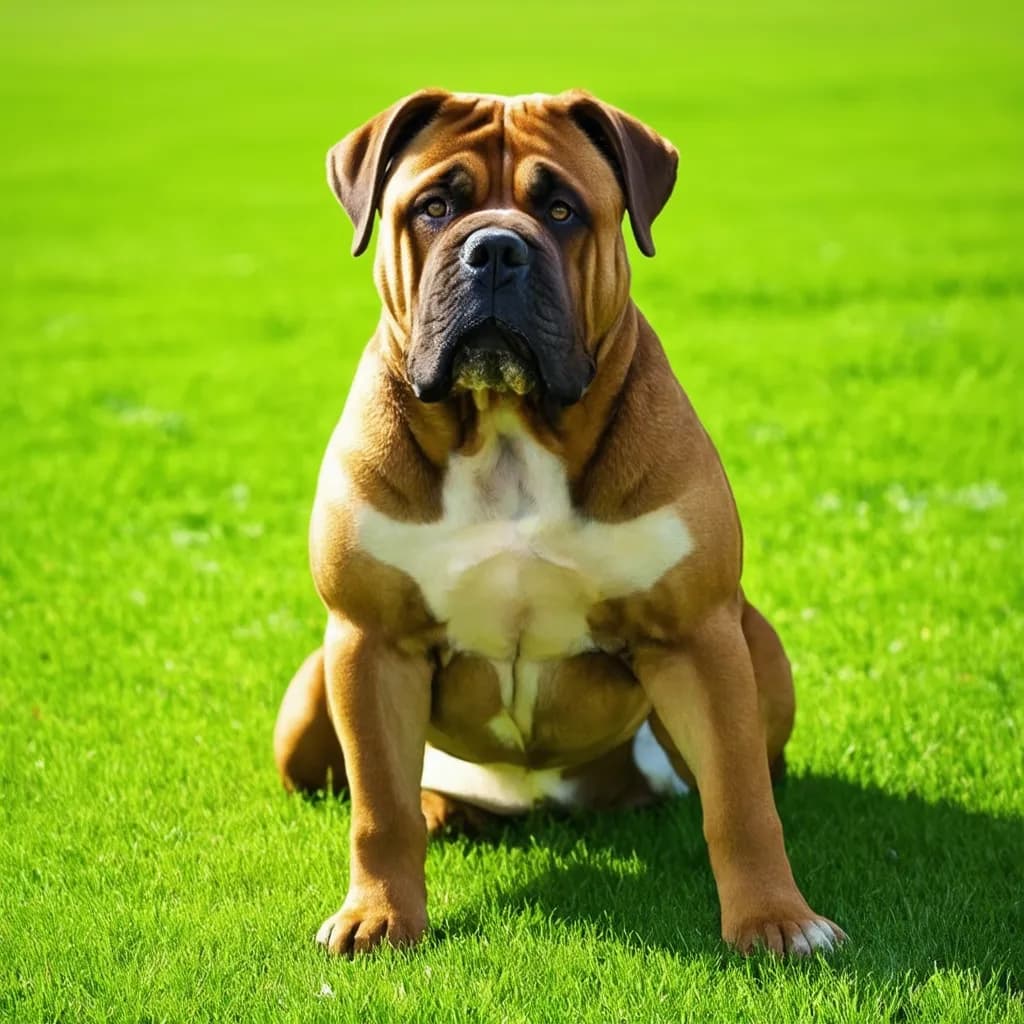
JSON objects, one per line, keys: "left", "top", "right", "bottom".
{"left": 384, "top": 93, "right": 623, "bottom": 213}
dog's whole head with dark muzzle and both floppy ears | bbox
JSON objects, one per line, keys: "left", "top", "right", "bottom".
{"left": 328, "top": 91, "right": 676, "bottom": 406}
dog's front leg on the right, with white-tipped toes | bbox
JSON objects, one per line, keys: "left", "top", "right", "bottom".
{"left": 634, "top": 602, "right": 845, "bottom": 955}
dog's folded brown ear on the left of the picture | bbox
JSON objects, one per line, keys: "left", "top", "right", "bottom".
{"left": 327, "top": 89, "right": 450, "bottom": 256}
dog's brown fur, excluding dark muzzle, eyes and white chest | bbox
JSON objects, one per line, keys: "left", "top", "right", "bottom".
{"left": 275, "top": 92, "right": 841, "bottom": 953}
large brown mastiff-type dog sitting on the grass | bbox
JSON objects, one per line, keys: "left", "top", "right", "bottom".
{"left": 274, "top": 91, "right": 844, "bottom": 954}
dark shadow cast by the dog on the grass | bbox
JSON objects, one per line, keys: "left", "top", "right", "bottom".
{"left": 433, "top": 775, "right": 1024, "bottom": 990}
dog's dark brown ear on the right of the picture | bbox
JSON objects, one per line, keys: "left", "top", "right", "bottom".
{"left": 566, "top": 89, "right": 679, "bottom": 256}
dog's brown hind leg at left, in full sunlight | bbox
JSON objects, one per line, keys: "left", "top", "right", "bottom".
{"left": 273, "top": 647, "right": 345, "bottom": 793}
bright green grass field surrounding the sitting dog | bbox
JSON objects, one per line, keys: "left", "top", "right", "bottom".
{"left": 0, "top": 0, "right": 1024, "bottom": 1024}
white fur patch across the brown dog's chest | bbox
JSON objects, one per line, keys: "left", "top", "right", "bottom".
{"left": 357, "top": 414, "right": 692, "bottom": 662}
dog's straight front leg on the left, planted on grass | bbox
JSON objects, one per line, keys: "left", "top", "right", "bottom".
{"left": 316, "top": 614, "right": 431, "bottom": 955}
